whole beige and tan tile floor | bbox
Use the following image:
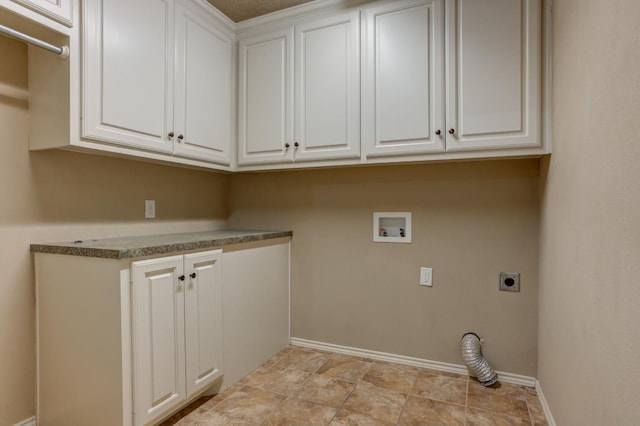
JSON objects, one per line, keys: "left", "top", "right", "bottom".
{"left": 162, "top": 346, "right": 547, "bottom": 426}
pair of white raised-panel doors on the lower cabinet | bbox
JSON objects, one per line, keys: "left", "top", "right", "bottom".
{"left": 131, "top": 250, "right": 222, "bottom": 425}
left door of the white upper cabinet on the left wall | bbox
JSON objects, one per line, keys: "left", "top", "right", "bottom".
{"left": 82, "top": 0, "right": 173, "bottom": 152}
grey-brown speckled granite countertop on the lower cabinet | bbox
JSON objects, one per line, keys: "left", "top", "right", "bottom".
{"left": 31, "top": 230, "right": 293, "bottom": 259}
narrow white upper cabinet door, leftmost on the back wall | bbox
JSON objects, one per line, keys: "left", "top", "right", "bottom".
{"left": 238, "top": 28, "right": 293, "bottom": 164}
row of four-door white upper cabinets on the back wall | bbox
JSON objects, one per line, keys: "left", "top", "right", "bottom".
{"left": 238, "top": 0, "right": 547, "bottom": 169}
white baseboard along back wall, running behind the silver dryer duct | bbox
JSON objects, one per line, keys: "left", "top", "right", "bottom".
{"left": 290, "top": 337, "right": 536, "bottom": 388}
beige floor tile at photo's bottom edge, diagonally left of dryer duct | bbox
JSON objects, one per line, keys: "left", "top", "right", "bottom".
{"left": 398, "top": 396, "right": 465, "bottom": 426}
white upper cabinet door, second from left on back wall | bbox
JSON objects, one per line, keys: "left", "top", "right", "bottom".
{"left": 294, "top": 11, "right": 360, "bottom": 161}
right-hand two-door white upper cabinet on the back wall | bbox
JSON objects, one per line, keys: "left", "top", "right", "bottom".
{"left": 362, "top": 0, "right": 542, "bottom": 162}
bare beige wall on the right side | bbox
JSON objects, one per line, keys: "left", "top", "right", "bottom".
{"left": 538, "top": 0, "right": 640, "bottom": 425}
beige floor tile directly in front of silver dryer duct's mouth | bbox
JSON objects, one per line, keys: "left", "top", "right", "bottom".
{"left": 467, "top": 380, "right": 529, "bottom": 420}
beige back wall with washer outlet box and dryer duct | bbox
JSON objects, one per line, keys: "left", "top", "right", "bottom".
{"left": 228, "top": 160, "right": 539, "bottom": 376}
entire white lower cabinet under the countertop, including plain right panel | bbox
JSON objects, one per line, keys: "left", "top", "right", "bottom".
{"left": 34, "top": 237, "right": 291, "bottom": 426}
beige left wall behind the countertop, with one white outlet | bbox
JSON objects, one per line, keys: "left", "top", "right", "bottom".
{"left": 0, "top": 37, "right": 226, "bottom": 425}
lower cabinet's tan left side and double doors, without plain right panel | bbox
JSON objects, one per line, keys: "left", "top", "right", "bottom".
{"left": 35, "top": 250, "right": 224, "bottom": 426}
